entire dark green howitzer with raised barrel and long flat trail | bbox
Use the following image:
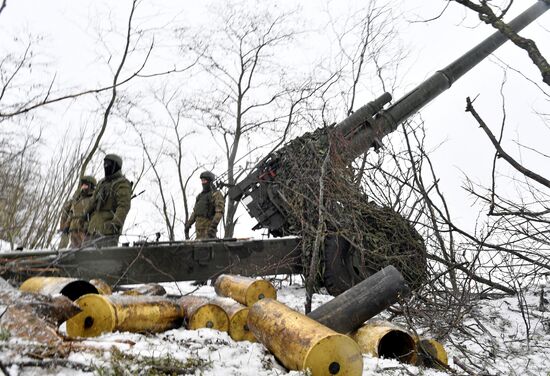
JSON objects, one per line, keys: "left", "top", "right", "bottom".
{"left": 0, "top": 0, "right": 550, "bottom": 295}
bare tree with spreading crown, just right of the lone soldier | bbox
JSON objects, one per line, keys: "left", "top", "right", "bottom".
{"left": 183, "top": 3, "right": 332, "bottom": 237}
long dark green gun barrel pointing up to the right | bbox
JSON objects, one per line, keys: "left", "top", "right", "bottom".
{"left": 339, "top": 0, "right": 550, "bottom": 161}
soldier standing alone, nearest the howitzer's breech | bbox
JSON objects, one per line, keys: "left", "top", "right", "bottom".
{"left": 185, "top": 171, "right": 225, "bottom": 239}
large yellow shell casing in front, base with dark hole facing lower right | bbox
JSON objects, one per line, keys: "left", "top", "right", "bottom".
{"left": 248, "top": 299, "right": 363, "bottom": 376}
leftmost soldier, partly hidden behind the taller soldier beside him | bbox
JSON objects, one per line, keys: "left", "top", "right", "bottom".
{"left": 61, "top": 176, "right": 97, "bottom": 248}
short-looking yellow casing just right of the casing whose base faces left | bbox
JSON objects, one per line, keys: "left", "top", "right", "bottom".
{"left": 178, "top": 295, "right": 229, "bottom": 332}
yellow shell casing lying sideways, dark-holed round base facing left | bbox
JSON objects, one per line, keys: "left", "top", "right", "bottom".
{"left": 67, "top": 294, "right": 184, "bottom": 337}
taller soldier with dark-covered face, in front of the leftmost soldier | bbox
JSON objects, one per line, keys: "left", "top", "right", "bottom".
{"left": 86, "top": 154, "right": 132, "bottom": 247}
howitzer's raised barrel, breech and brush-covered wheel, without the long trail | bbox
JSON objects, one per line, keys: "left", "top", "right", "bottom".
{"left": 229, "top": 1, "right": 550, "bottom": 294}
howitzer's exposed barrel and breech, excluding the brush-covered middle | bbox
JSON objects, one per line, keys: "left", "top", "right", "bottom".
{"left": 229, "top": 0, "right": 550, "bottom": 237}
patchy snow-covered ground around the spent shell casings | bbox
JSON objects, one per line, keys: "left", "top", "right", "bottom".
{"left": 0, "top": 280, "right": 550, "bottom": 376}
